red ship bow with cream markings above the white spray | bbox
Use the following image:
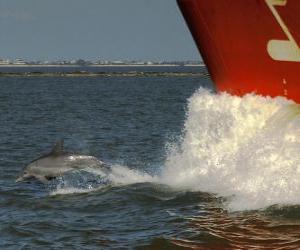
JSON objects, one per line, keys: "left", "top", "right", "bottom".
{"left": 178, "top": 0, "right": 300, "bottom": 103}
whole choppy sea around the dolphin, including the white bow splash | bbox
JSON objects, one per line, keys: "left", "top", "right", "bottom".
{"left": 0, "top": 68, "right": 300, "bottom": 249}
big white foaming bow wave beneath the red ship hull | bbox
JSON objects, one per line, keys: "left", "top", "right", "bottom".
{"left": 161, "top": 89, "right": 300, "bottom": 210}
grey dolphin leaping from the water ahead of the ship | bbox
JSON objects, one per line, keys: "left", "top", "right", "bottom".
{"left": 16, "top": 140, "right": 105, "bottom": 183}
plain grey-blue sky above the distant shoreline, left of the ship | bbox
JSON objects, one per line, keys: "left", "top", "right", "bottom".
{"left": 0, "top": 0, "right": 200, "bottom": 61}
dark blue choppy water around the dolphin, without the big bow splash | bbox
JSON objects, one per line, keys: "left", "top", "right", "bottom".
{"left": 0, "top": 67, "right": 300, "bottom": 249}
